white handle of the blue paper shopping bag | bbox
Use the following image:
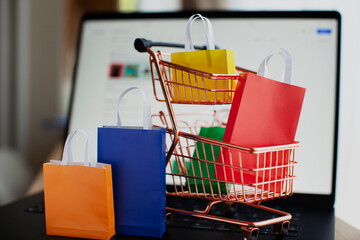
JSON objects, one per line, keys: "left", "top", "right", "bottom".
{"left": 116, "top": 87, "right": 152, "bottom": 130}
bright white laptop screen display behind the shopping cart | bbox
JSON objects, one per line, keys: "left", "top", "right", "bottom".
{"left": 68, "top": 12, "right": 340, "bottom": 195}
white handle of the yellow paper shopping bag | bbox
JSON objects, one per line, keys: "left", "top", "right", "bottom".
{"left": 185, "top": 13, "right": 215, "bottom": 52}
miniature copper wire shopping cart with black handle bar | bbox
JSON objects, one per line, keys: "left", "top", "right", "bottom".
{"left": 135, "top": 39, "right": 299, "bottom": 240}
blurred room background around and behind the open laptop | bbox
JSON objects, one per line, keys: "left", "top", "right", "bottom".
{"left": 0, "top": 0, "right": 360, "bottom": 232}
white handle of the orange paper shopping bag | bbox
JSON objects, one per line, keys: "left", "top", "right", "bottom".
{"left": 61, "top": 129, "right": 97, "bottom": 167}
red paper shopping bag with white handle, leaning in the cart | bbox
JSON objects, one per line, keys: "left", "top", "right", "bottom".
{"left": 217, "top": 49, "right": 305, "bottom": 193}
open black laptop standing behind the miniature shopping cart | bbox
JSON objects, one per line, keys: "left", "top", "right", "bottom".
{"left": 0, "top": 11, "right": 341, "bottom": 240}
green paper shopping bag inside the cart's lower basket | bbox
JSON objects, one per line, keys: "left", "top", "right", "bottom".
{"left": 187, "top": 127, "right": 227, "bottom": 194}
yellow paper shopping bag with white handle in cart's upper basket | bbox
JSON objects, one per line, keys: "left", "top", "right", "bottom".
{"left": 171, "top": 14, "right": 236, "bottom": 103}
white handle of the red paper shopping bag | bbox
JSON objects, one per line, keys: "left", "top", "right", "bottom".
{"left": 257, "top": 48, "right": 292, "bottom": 84}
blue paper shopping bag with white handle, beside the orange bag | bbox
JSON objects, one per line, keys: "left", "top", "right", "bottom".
{"left": 98, "top": 87, "right": 166, "bottom": 238}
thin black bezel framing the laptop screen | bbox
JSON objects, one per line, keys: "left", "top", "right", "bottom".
{"left": 64, "top": 11, "right": 341, "bottom": 208}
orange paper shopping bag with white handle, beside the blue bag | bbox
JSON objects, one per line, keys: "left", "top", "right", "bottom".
{"left": 43, "top": 129, "right": 115, "bottom": 240}
